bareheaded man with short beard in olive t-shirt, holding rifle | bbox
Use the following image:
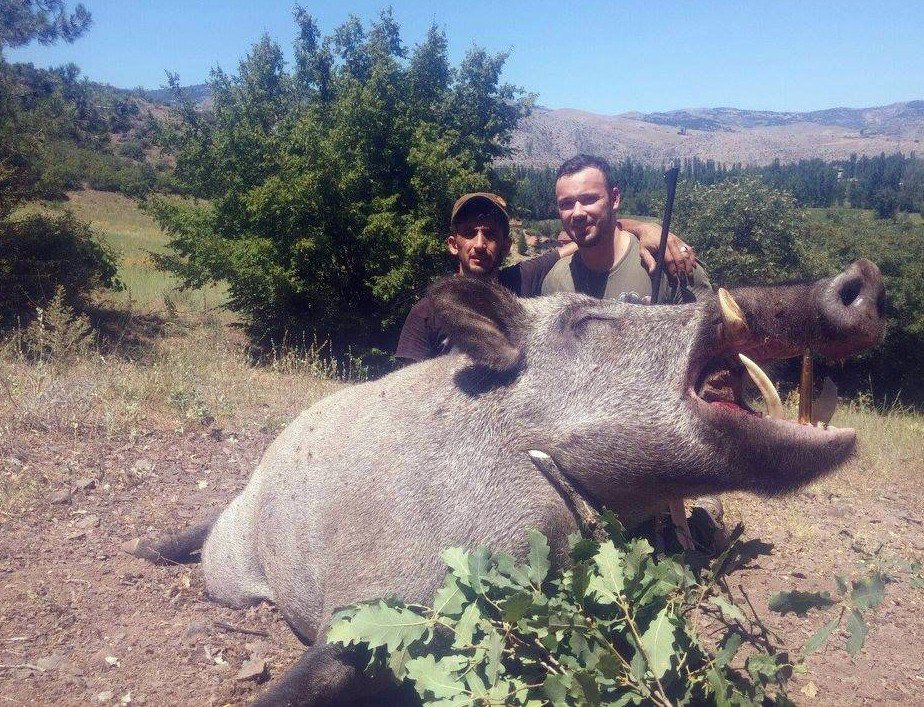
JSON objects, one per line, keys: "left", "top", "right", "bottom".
{"left": 542, "top": 155, "right": 712, "bottom": 303}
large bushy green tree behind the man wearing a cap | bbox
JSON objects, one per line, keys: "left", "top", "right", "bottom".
{"left": 152, "top": 8, "right": 528, "bottom": 351}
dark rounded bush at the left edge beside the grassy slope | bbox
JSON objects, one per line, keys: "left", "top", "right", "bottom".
{"left": 0, "top": 213, "right": 121, "bottom": 325}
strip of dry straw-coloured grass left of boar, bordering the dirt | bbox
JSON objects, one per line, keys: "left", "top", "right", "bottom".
{"left": 0, "top": 317, "right": 344, "bottom": 512}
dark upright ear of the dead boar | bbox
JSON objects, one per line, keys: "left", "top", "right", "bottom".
{"left": 429, "top": 275, "right": 526, "bottom": 373}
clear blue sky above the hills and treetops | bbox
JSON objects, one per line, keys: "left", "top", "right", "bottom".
{"left": 6, "top": 0, "right": 924, "bottom": 114}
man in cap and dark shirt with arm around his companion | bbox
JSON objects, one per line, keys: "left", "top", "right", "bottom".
{"left": 395, "top": 192, "right": 695, "bottom": 363}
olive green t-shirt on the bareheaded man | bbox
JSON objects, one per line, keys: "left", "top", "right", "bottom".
{"left": 542, "top": 238, "right": 712, "bottom": 304}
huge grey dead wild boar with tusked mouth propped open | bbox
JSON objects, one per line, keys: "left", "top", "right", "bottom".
{"left": 131, "top": 260, "right": 884, "bottom": 704}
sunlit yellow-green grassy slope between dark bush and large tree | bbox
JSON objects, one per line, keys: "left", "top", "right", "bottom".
{"left": 18, "top": 189, "right": 227, "bottom": 312}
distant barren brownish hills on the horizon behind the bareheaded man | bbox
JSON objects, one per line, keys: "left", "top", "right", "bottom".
{"left": 511, "top": 101, "right": 924, "bottom": 166}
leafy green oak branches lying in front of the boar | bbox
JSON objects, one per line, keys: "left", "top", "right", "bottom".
{"left": 328, "top": 513, "right": 886, "bottom": 706}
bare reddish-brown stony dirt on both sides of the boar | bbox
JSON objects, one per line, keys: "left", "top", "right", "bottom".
{"left": 0, "top": 396, "right": 924, "bottom": 705}
